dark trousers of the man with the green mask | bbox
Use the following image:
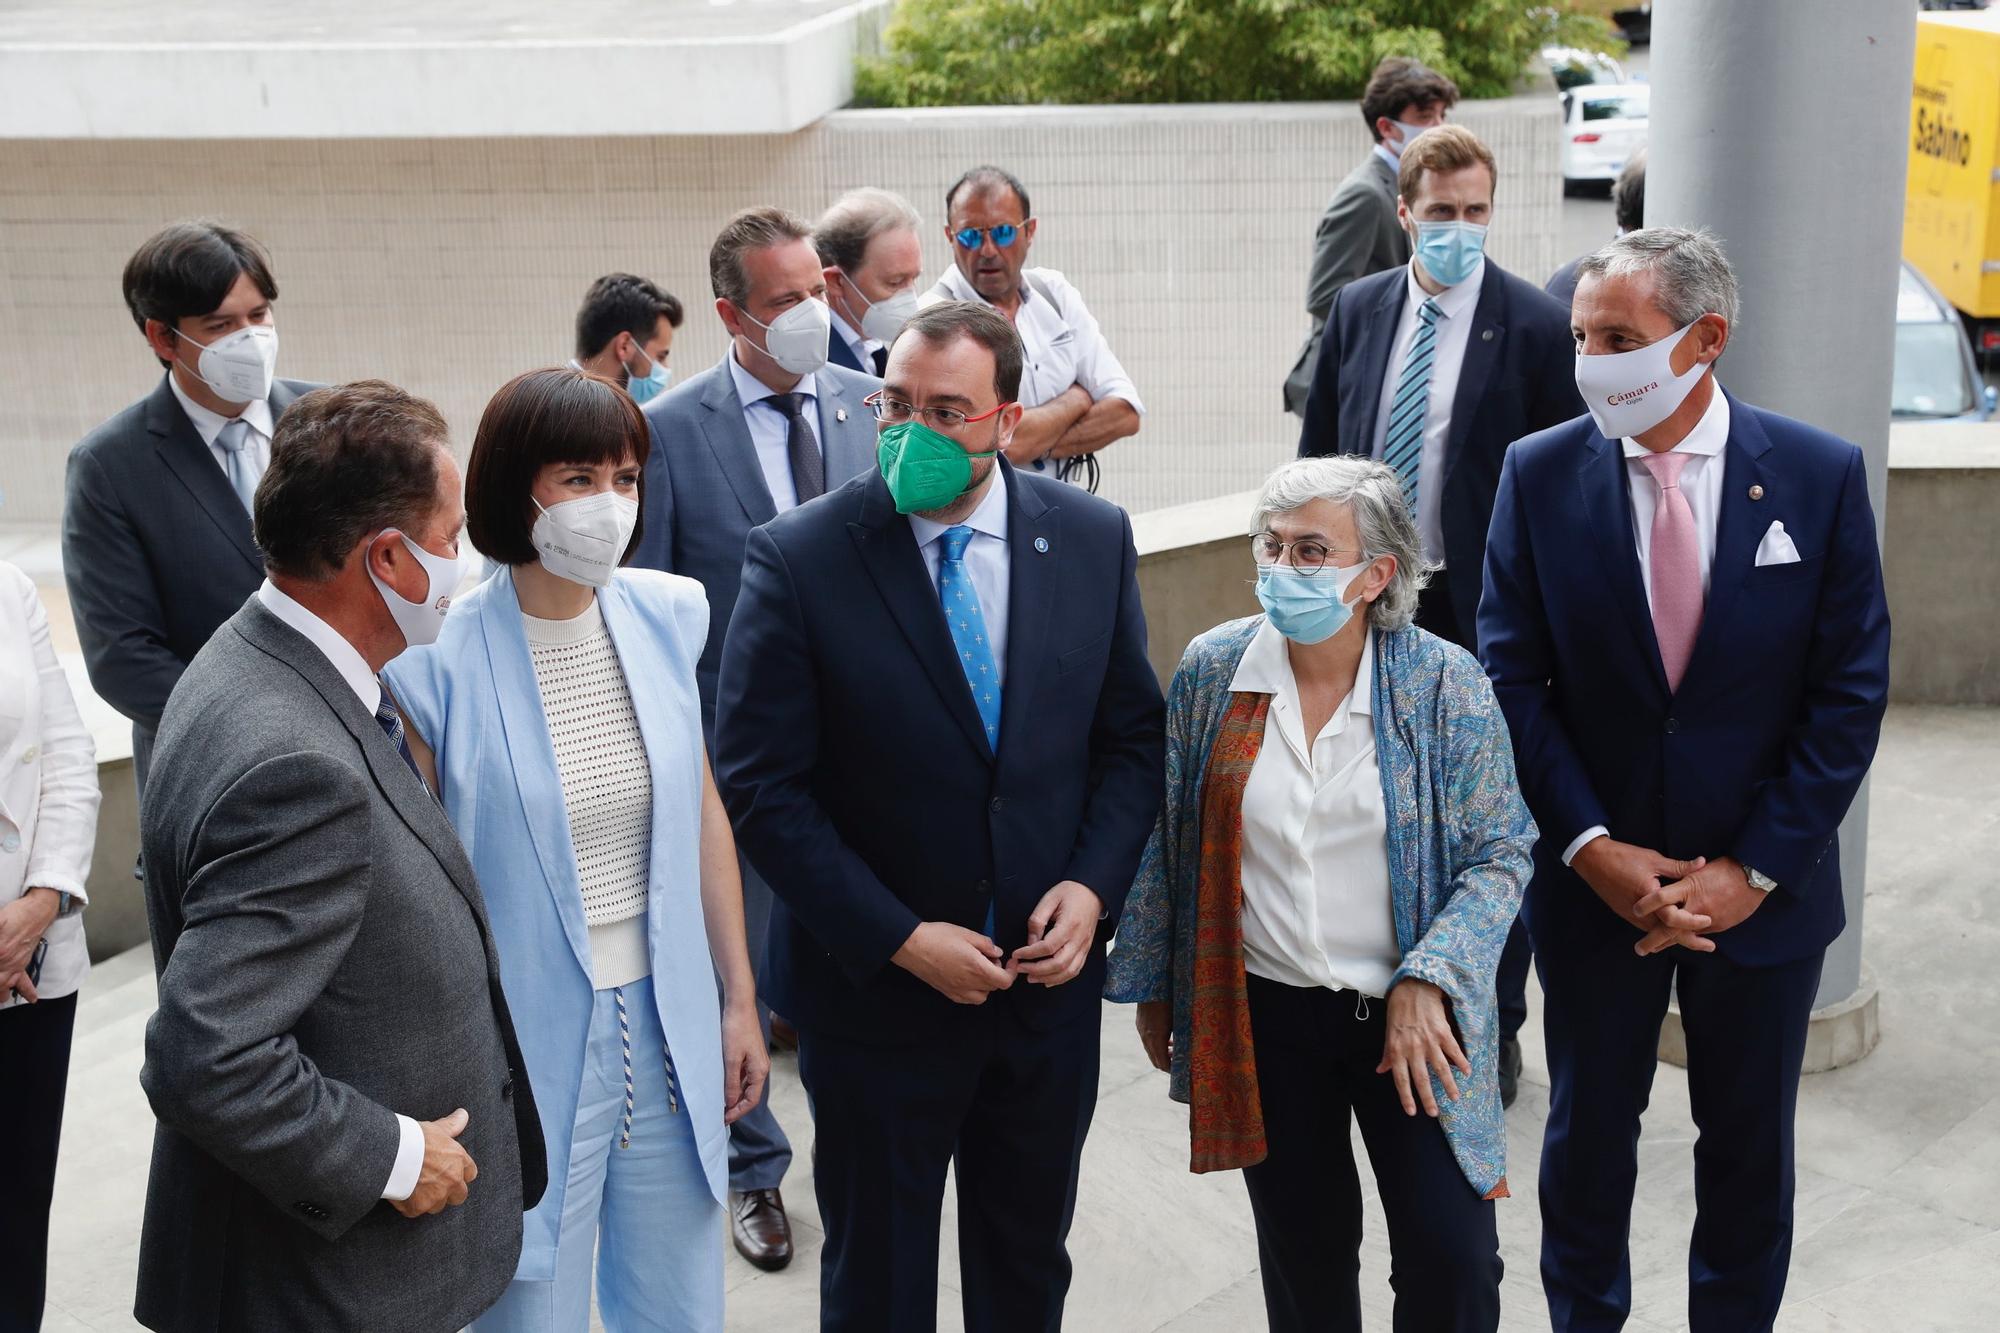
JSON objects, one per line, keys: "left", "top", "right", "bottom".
{"left": 798, "top": 996, "right": 1098, "bottom": 1333}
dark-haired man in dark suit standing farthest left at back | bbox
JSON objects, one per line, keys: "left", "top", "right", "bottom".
{"left": 62, "top": 222, "right": 314, "bottom": 793}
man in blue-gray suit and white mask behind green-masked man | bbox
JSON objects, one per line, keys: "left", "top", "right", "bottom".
{"left": 632, "top": 208, "right": 882, "bottom": 1269}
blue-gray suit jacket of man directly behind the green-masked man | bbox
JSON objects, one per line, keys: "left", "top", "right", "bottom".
{"left": 632, "top": 352, "right": 882, "bottom": 736}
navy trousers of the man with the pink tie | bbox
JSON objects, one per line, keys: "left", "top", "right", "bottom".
{"left": 1536, "top": 932, "right": 1824, "bottom": 1333}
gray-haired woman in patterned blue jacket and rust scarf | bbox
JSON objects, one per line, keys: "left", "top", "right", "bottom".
{"left": 1106, "top": 458, "right": 1536, "bottom": 1333}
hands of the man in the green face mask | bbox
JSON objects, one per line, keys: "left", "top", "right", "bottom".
{"left": 890, "top": 879, "right": 1104, "bottom": 1005}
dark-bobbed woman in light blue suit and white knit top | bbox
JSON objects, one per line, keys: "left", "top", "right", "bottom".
{"left": 386, "top": 370, "right": 770, "bottom": 1333}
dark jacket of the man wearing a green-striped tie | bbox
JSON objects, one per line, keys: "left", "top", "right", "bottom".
{"left": 1298, "top": 258, "right": 1584, "bottom": 626}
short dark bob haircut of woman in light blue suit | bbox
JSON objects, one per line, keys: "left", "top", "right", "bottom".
{"left": 466, "top": 368, "right": 652, "bottom": 564}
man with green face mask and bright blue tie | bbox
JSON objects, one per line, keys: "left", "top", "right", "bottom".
{"left": 716, "top": 302, "right": 1164, "bottom": 1331}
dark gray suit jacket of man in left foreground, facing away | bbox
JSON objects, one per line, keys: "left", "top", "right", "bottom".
{"left": 136, "top": 598, "right": 548, "bottom": 1333}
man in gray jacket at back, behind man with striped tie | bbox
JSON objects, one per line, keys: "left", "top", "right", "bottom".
{"left": 1284, "top": 56, "right": 1458, "bottom": 416}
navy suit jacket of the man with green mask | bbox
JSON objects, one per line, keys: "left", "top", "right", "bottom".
{"left": 716, "top": 462, "right": 1166, "bottom": 1043}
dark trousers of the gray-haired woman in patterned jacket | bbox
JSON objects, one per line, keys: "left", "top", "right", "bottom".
{"left": 1244, "top": 964, "right": 1500, "bottom": 1333}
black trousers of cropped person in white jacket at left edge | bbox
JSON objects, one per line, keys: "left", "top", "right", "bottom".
{"left": 0, "top": 995, "right": 76, "bottom": 1333}
